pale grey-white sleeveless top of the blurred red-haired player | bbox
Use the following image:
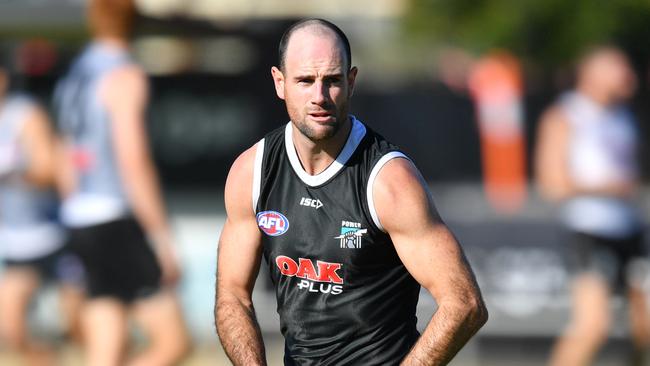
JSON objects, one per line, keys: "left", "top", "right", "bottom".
{"left": 54, "top": 43, "right": 131, "bottom": 227}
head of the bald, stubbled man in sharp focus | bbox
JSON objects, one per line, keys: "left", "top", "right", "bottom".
{"left": 271, "top": 29, "right": 357, "bottom": 141}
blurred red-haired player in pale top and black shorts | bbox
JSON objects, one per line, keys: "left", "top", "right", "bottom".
{"left": 55, "top": 0, "right": 188, "bottom": 366}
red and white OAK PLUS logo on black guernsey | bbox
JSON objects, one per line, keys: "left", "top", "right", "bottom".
{"left": 275, "top": 255, "right": 343, "bottom": 295}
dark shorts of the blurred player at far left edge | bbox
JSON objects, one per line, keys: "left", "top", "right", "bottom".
{"left": 2, "top": 245, "right": 85, "bottom": 287}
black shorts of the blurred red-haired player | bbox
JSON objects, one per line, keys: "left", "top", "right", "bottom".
{"left": 69, "top": 218, "right": 161, "bottom": 303}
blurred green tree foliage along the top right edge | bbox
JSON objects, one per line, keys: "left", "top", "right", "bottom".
{"left": 404, "top": 0, "right": 650, "bottom": 66}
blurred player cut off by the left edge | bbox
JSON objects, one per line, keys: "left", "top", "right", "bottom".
{"left": 0, "top": 63, "right": 82, "bottom": 365}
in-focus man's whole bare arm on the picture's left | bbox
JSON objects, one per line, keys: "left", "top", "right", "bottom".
{"left": 215, "top": 147, "right": 266, "bottom": 366}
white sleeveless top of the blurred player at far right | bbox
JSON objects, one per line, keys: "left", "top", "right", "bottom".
{"left": 560, "top": 92, "right": 640, "bottom": 238}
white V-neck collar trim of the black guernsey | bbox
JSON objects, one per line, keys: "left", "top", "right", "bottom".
{"left": 284, "top": 116, "right": 366, "bottom": 187}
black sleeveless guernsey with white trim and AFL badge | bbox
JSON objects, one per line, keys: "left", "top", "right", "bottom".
{"left": 253, "top": 117, "right": 420, "bottom": 365}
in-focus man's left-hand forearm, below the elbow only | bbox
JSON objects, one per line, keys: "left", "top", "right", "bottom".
{"left": 215, "top": 295, "right": 266, "bottom": 366}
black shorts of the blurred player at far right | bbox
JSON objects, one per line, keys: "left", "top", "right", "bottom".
{"left": 570, "top": 232, "right": 648, "bottom": 291}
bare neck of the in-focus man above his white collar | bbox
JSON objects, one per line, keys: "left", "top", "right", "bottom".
{"left": 291, "top": 117, "right": 352, "bottom": 175}
